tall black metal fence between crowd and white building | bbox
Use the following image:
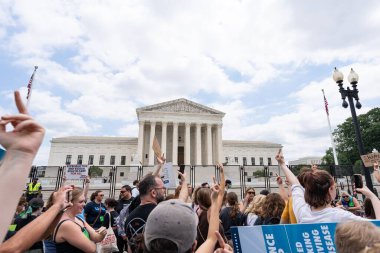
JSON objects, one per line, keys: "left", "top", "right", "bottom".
{"left": 29, "top": 165, "right": 379, "bottom": 201}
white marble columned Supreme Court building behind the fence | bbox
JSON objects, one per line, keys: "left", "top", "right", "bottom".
{"left": 48, "top": 98, "right": 282, "bottom": 166}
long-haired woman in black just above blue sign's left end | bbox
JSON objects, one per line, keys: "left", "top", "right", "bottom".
{"left": 219, "top": 192, "right": 243, "bottom": 240}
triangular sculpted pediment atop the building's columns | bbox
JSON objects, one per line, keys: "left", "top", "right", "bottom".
{"left": 136, "top": 98, "right": 225, "bottom": 115}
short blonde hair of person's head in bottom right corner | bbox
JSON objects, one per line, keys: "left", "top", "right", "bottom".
{"left": 335, "top": 221, "right": 380, "bottom": 253}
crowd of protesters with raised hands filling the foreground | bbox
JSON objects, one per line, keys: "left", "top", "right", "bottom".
{"left": 0, "top": 92, "right": 380, "bottom": 253}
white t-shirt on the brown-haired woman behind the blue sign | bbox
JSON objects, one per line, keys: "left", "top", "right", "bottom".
{"left": 292, "top": 184, "right": 368, "bottom": 223}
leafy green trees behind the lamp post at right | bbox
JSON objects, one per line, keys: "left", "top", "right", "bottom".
{"left": 323, "top": 108, "right": 380, "bottom": 166}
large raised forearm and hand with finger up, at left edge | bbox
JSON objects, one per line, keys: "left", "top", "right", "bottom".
{"left": 0, "top": 91, "right": 45, "bottom": 241}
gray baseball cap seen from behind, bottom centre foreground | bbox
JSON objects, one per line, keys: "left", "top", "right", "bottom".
{"left": 144, "top": 199, "right": 198, "bottom": 253}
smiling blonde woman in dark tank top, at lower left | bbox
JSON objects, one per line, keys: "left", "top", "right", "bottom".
{"left": 53, "top": 187, "right": 107, "bottom": 253}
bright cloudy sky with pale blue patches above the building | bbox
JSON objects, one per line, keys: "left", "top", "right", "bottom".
{"left": 0, "top": 0, "right": 380, "bottom": 165}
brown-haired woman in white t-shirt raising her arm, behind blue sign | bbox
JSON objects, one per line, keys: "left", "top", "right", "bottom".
{"left": 276, "top": 149, "right": 380, "bottom": 223}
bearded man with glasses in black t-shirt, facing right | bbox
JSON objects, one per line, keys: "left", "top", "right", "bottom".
{"left": 125, "top": 174, "right": 166, "bottom": 252}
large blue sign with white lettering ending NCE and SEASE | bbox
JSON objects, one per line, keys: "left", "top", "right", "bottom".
{"left": 231, "top": 221, "right": 380, "bottom": 253}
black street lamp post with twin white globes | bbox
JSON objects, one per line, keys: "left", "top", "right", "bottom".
{"left": 333, "top": 68, "right": 374, "bottom": 192}
